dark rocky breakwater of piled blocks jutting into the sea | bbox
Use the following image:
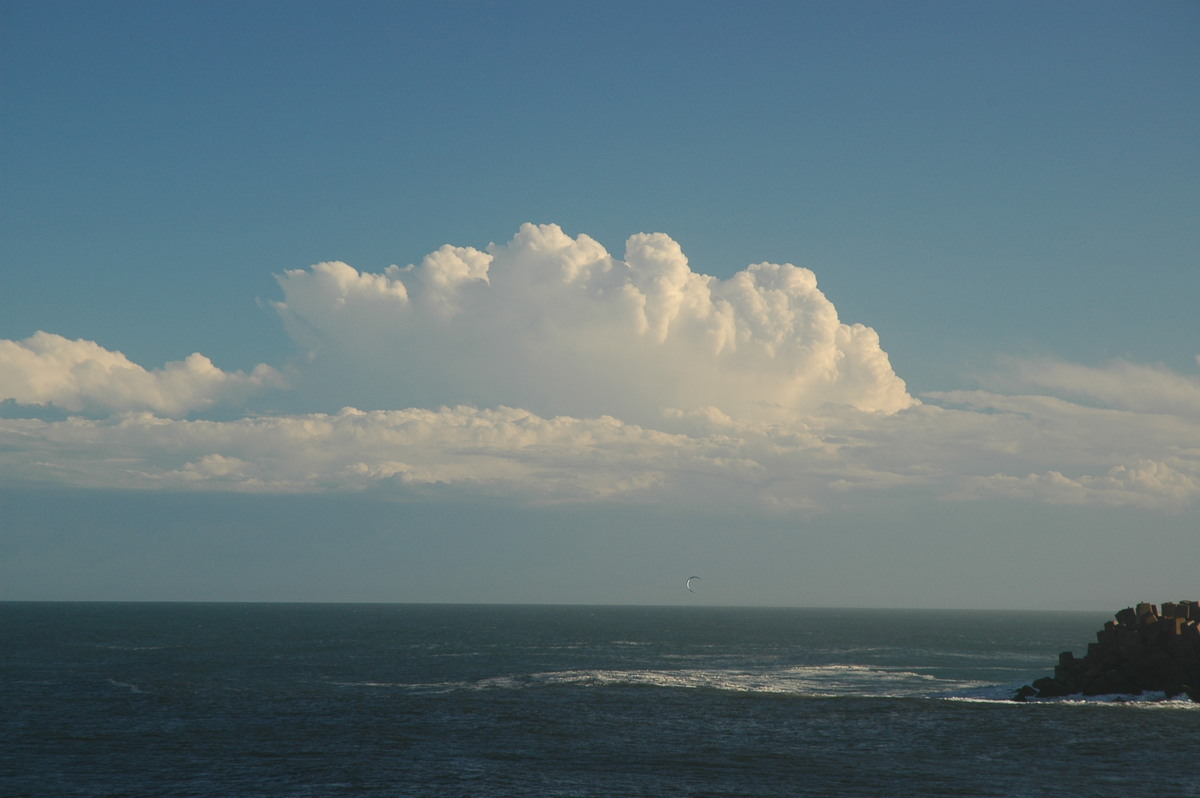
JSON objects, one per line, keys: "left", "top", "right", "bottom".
{"left": 1013, "top": 601, "right": 1200, "bottom": 702}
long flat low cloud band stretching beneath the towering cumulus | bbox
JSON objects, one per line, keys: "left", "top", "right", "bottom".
{"left": 0, "top": 391, "right": 1200, "bottom": 514}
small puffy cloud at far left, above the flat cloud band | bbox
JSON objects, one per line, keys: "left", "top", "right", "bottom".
{"left": 0, "top": 331, "right": 282, "bottom": 415}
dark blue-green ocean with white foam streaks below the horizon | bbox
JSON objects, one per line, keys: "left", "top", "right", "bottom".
{"left": 0, "top": 602, "right": 1200, "bottom": 798}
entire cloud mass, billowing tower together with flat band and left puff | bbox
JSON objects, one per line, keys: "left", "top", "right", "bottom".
{"left": 0, "top": 224, "right": 1200, "bottom": 514}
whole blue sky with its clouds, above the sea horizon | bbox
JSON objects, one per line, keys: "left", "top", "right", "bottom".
{"left": 0, "top": 0, "right": 1200, "bottom": 611}
